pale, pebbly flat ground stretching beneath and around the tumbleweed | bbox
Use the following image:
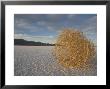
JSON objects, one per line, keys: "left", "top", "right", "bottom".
{"left": 14, "top": 46, "right": 97, "bottom": 76}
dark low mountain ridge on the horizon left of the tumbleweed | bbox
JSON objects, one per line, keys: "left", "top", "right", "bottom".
{"left": 14, "top": 39, "right": 55, "bottom": 46}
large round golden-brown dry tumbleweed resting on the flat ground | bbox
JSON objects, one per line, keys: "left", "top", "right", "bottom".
{"left": 54, "top": 29, "right": 95, "bottom": 68}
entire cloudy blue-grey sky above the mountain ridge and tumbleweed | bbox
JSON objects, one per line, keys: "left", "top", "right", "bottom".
{"left": 14, "top": 14, "right": 97, "bottom": 44}
